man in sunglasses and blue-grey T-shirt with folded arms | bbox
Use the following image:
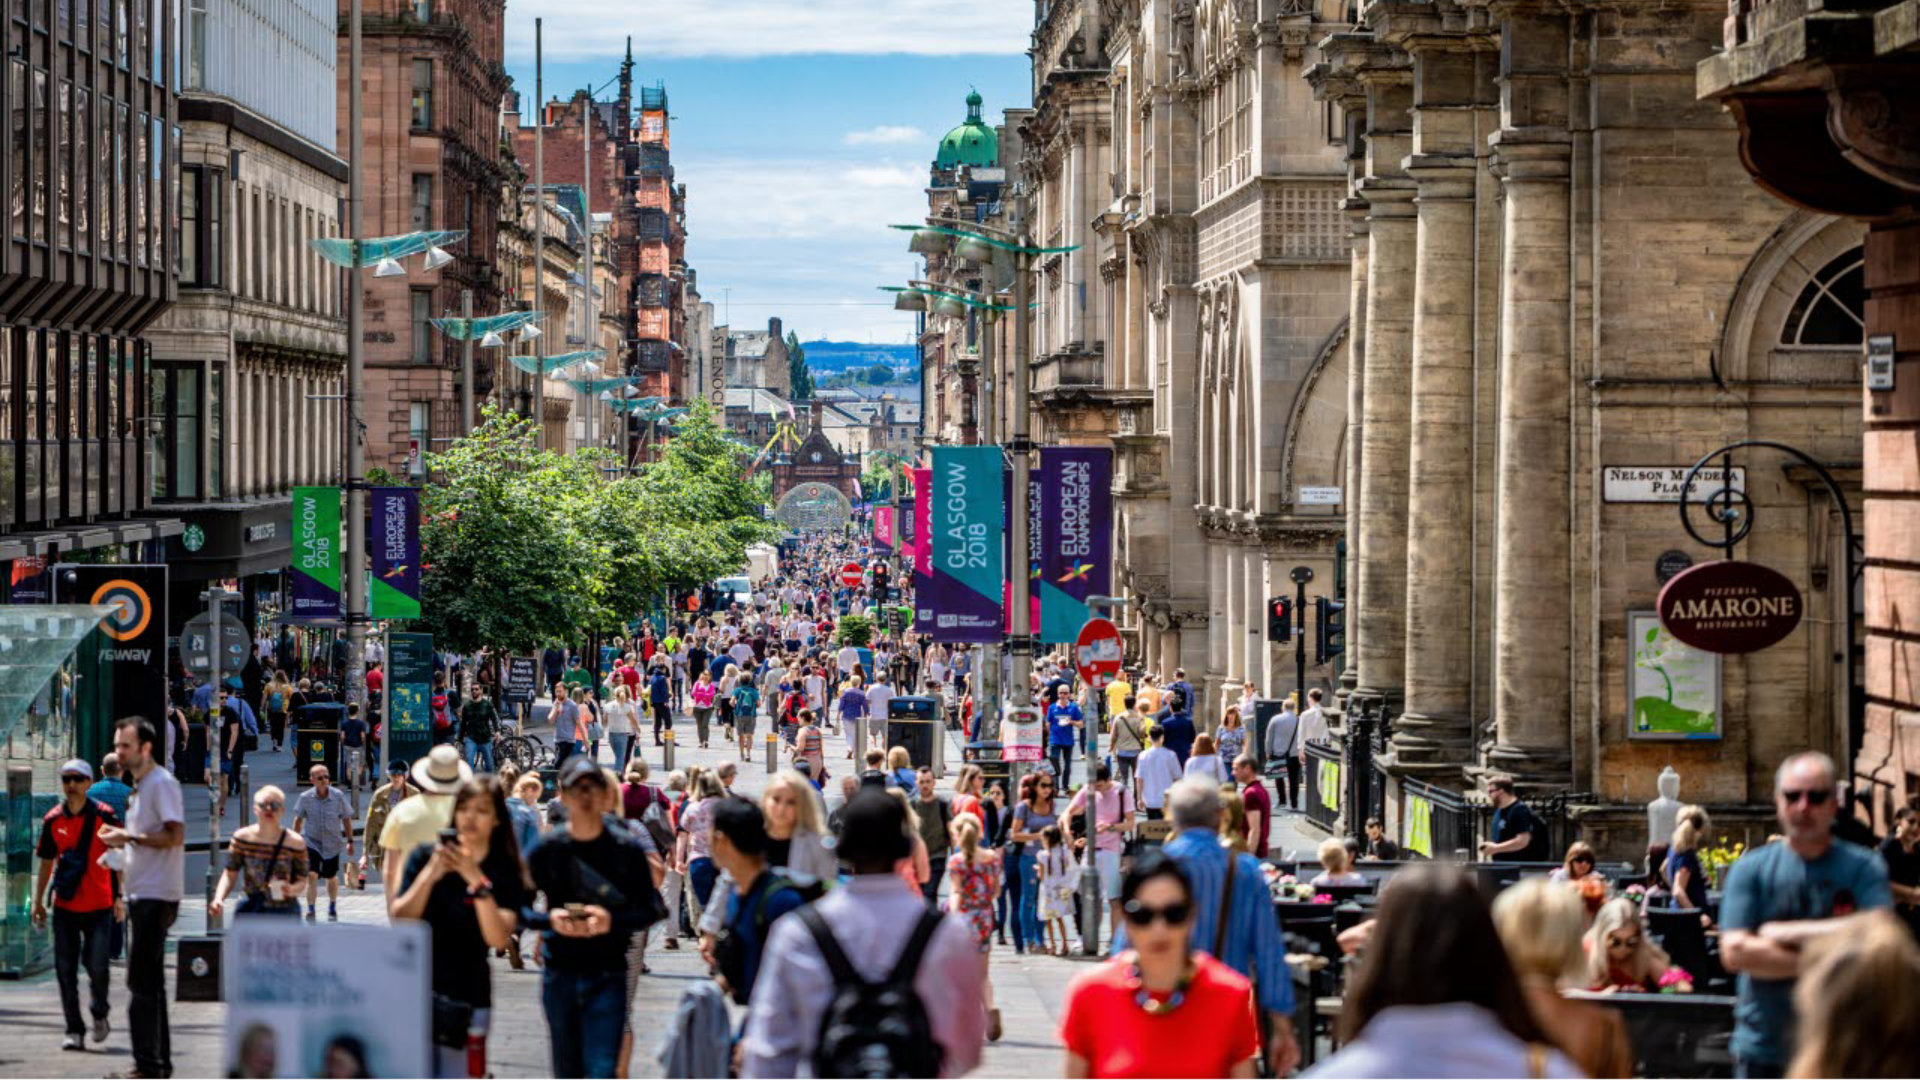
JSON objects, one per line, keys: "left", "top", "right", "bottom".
{"left": 1720, "top": 751, "right": 1893, "bottom": 1076}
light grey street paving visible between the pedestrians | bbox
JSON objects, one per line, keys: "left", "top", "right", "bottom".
{"left": 0, "top": 691, "right": 1319, "bottom": 1078}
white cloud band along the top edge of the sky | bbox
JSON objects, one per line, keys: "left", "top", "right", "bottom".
{"left": 507, "top": 0, "right": 1033, "bottom": 60}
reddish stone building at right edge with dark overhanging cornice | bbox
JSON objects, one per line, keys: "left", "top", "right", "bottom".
{"left": 1695, "top": 0, "right": 1920, "bottom": 830}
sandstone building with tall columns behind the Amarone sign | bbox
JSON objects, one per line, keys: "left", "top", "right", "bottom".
{"left": 1306, "top": 0, "right": 1860, "bottom": 855}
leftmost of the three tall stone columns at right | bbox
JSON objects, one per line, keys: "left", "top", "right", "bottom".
{"left": 1354, "top": 67, "right": 1415, "bottom": 713}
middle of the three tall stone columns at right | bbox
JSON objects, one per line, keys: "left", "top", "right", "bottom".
{"left": 1392, "top": 38, "right": 1476, "bottom": 764}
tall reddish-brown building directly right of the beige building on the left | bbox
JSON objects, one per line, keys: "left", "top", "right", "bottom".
{"left": 338, "top": 0, "right": 509, "bottom": 473}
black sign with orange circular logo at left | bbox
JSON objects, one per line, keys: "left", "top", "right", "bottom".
{"left": 50, "top": 563, "right": 168, "bottom": 763}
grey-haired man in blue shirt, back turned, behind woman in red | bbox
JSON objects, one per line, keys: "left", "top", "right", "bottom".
{"left": 1114, "top": 772, "right": 1300, "bottom": 1076}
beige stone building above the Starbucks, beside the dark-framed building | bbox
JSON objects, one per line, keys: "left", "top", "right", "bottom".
{"left": 148, "top": 0, "right": 348, "bottom": 626}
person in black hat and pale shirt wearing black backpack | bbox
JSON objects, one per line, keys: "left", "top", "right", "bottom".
{"left": 741, "top": 788, "right": 987, "bottom": 1076}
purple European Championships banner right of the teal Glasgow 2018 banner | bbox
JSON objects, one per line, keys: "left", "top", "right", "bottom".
{"left": 1033, "top": 446, "right": 1114, "bottom": 642}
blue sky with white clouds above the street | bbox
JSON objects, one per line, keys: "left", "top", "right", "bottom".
{"left": 507, "top": 0, "right": 1033, "bottom": 342}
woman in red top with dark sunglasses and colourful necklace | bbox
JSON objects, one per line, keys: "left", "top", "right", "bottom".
{"left": 1060, "top": 851, "right": 1260, "bottom": 1078}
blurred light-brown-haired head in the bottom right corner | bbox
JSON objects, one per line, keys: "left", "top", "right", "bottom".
{"left": 1788, "top": 911, "right": 1920, "bottom": 1078}
